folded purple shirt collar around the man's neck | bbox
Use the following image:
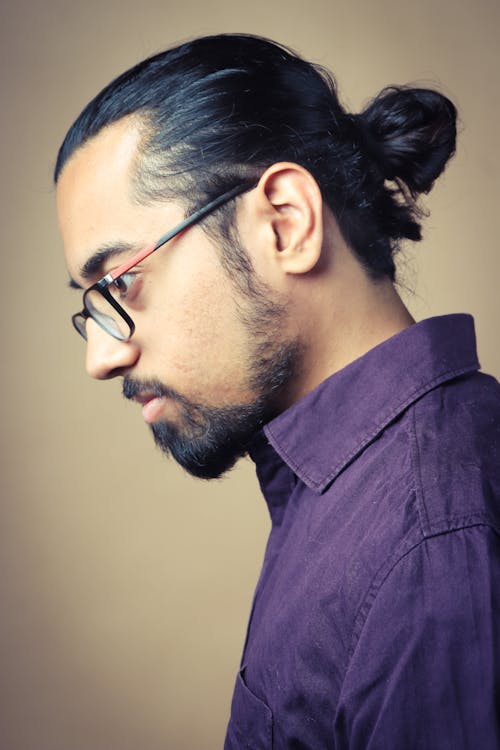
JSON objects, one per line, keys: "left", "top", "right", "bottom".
{"left": 257, "top": 314, "right": 479, "bottom": 492}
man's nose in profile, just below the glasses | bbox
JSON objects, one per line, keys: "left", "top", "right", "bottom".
{"left": 85, "top": 320, "right": 139, "bottom": 380}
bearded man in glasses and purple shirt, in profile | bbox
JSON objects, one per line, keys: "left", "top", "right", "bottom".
{"left": 55, "top": 35, "right": 500, "bottom": 750}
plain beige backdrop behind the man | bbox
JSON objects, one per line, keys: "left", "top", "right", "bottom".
{"left": 0, "top": 0, "right": 500, "bottom": 750}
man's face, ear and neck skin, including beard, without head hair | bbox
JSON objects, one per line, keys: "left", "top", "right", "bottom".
{"left": 57, "top": 118, "right": 413, "bottom": 478}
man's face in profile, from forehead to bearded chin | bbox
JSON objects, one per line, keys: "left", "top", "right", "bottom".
{"left": 57, "top": 120, "right": 299, "bottom": 478}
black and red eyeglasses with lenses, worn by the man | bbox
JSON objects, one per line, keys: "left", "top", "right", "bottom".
{"left": 71, "top": 182, "right": 257, "bottom": 341}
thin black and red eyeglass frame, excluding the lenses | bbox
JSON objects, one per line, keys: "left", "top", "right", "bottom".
{"left": 71, "top": 181, "right": 257, "bottom": 342}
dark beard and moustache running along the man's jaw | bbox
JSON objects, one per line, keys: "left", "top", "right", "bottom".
{"left": 123, "top": 258, "right": 302, "bottom": 479}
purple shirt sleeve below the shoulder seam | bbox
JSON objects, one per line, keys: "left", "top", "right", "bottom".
{"left": 334, "top": 525, "right": 500, "bottom": 750}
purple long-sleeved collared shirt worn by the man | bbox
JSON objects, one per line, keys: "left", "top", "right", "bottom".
{"left": 224, "top": 315, "right": 500, "bottom": 750}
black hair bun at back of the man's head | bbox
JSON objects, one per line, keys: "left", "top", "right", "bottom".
{"left": 355, "top": 86, "right": 457, "bottom": 195}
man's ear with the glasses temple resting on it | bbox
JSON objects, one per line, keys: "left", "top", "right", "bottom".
{"left": 256, "top": 162, "right": 323, "bottom": 274}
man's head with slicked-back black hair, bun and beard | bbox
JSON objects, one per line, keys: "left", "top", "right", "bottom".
{"left": 55, "top": 35, "right": 454, "bottom": 476}
